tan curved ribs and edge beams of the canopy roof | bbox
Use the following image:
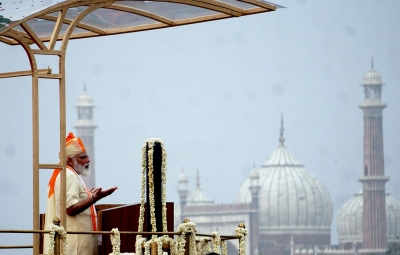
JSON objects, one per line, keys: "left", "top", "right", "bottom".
{"left": 0, "top": 0, "right": 277, "bottom": 44}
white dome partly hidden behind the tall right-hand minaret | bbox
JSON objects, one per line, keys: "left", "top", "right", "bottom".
{"left": 337, "top": 189, "right": 400, "bottom": 244}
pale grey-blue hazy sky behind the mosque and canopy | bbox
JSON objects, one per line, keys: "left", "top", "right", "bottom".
{"left": 0, "top": 0, "right": 400, "bottom": 254}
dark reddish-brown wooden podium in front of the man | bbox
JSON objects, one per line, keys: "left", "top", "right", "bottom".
{"left": 96, "top": 202, "right": 174, "bottom": 255}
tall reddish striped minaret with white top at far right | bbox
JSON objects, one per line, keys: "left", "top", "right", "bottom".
{"left": 359, "top": 60, "right": 389, "bottom": 254}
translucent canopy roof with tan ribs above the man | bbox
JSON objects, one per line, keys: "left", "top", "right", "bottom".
{"left": 0, "top": 0, "right": 279, "bottom": 44}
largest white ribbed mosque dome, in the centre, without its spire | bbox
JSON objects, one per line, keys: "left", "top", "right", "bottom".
{"left": 235, "top": 145, "right": 333, "bottom": 234}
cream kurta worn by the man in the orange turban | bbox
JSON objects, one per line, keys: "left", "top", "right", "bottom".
{"left": 43, "top": 168, "right": 98, "bottom": 255}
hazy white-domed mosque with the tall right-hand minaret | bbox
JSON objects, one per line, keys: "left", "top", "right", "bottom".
{"left": 175, "top": 62, "right": 400, "bottom": 255}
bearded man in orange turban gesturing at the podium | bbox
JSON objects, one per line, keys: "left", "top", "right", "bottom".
{"left": 43, "top": 132, "right": 117, "bottom": 255}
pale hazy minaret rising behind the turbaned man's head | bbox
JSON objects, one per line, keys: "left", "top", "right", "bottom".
{"left": 74, "top": 84, "right": 97, "bottom": 189}
